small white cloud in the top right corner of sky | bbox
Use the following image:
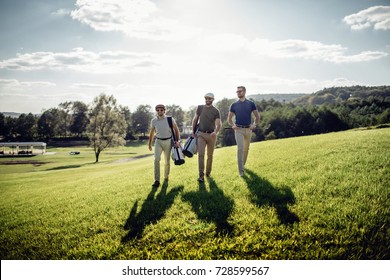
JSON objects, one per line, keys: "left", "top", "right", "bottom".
{"left": 343, "top": 6, "right": 390, "bottom": 30}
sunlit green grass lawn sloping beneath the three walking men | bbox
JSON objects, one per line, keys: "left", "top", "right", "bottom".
{"left": 0, "top": 128, "right": 390, "bottom": 260}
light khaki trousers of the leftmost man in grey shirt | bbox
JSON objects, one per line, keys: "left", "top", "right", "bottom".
{"left": 154, "top": 139, "right": 172, "bottom": 181}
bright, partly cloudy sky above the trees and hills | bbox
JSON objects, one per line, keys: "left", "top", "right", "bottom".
{"left": 0, "top": 0, "right": 390, "bottom": 114}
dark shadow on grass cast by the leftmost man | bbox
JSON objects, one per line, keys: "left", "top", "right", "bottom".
{"left": 122, "top": 182, "right": 183, "bottom": 243}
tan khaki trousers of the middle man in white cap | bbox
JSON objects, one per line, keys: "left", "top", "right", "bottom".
{"left": 197, "top": 132, "right": 217, "bottom": 177}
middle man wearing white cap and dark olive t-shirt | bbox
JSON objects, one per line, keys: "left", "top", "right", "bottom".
{"left": 192, "top": 93, "right": 222, "bottom": 182}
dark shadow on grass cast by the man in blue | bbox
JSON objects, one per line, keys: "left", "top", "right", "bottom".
{"left": 243, "top": 169, "right": 299, "bottom": 225}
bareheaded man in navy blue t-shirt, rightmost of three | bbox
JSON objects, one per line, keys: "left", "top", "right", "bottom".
{"left": 228, "top": 86, "right": 260, "bottom": 176}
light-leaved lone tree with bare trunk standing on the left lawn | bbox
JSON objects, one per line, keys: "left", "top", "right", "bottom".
{"left": 87, "top": 94, "right": 126, "bottom": 162}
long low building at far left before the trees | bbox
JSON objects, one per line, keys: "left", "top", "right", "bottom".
{"left": 0, "top": 142, "right": 46, "bottom": 156}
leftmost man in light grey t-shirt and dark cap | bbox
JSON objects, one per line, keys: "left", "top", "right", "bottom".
{"left": 149, "top": 104, "right": 180, "bottom": 187}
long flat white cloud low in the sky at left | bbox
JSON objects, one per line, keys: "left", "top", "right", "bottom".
{"left": 0, "top": 48, "right": 159, "bottom": 74}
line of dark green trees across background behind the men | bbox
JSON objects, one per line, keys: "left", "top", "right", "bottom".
{"left": 0, "top": 86, "right": 390, "bottom": 153}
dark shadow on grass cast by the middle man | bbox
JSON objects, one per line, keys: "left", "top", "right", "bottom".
{"left": 182, "top": 178, "right": 234, "bottom": 235}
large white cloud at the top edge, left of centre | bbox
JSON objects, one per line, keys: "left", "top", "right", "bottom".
{"left": 71, "top": 0, "right": 199, "bottom": 41}
